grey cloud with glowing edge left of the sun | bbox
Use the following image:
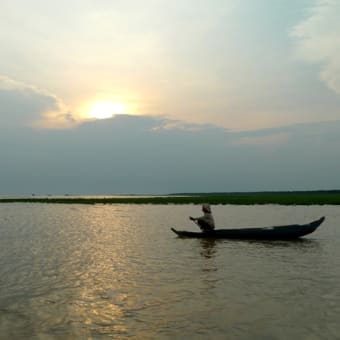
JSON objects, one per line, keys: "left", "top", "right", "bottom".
{"left": 0, "top": 75, "right": 75, "bottom": 128}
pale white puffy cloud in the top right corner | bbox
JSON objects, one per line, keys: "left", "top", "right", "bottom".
{"left": 292, "top": 0, "right": 340, "bottom": 94}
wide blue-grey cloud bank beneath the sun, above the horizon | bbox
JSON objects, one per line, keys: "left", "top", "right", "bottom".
{"left": 0, "top": 115, "right": 340, "bottom": 194}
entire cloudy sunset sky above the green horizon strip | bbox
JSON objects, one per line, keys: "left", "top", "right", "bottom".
{"left": 0, "top": 0, "right": 340, "bottom": 195}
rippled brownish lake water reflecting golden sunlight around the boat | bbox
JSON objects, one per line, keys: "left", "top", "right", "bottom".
{"left": 0, "top": 203, "right": 340, "bottom": 340}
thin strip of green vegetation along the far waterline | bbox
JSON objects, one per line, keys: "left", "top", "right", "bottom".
{"left": 0, "top": 190, "right": 340, "bottom": 205}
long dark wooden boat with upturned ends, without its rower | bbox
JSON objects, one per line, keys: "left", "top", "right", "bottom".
{"left": 171, "top": 217, "right": 325, "bottom": 240}
